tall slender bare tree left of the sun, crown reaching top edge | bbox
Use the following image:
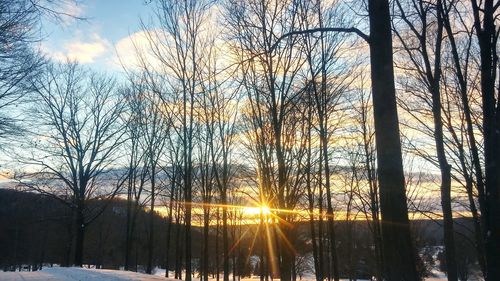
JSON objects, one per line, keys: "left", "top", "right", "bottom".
{"left": 139, "top": 0, "right": 215, "bottom": 281}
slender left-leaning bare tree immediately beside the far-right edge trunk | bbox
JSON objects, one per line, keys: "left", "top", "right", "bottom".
{"left": 441, "top": 0, "right": 486, "bottom": 275}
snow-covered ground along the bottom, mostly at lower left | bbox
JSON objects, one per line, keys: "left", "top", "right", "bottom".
{"left": 0, "top": 267, "right": 446, "bottom": 281}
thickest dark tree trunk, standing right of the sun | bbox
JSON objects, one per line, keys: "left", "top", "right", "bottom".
{"left": 368, "top": 0, "right": 419, "bottom": 281}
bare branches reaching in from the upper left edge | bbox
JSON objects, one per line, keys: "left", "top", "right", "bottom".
{"left": 0, "top": 0, "right": 67, "bottom": 142}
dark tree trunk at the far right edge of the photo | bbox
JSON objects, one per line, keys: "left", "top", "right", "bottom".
{"left": 472, "top": 0, "right": 500, "bottom": 281}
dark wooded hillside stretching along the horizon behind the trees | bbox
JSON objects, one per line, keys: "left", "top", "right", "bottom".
{"left": 0, "top": 189, "right": 474, "bottom": 272}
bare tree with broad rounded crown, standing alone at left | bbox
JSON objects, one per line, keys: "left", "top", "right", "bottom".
{"left": 17, "top": 64, "right": 126, "bottom": 266}
